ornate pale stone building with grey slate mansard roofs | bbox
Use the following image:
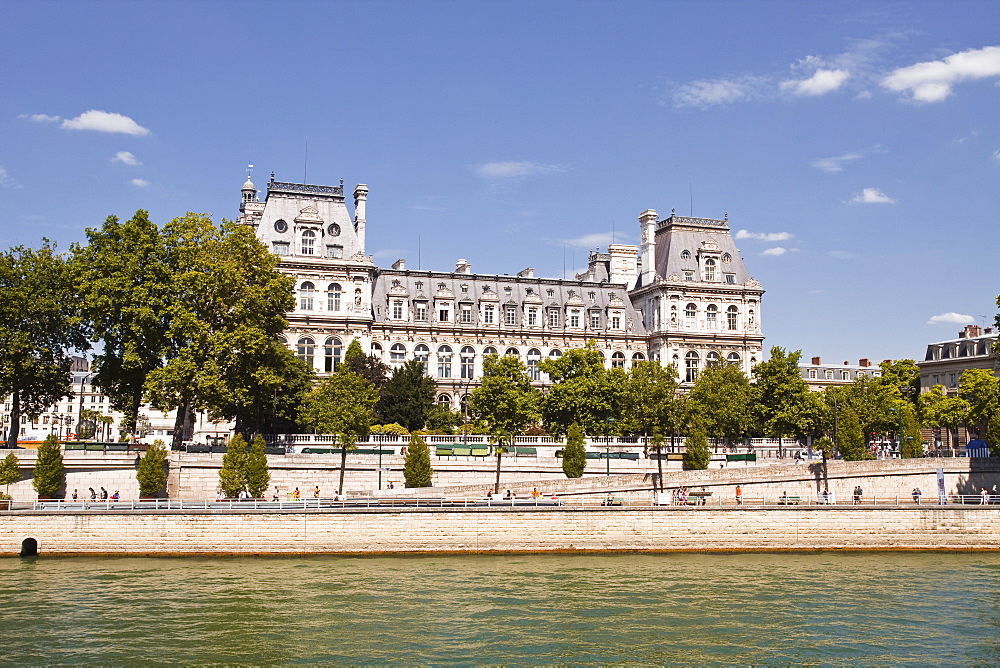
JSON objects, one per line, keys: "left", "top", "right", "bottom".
{"left": 238, "top": 173, "right": 764, "bottom": 409}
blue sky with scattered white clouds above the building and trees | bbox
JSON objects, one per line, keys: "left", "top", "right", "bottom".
{"left": 0, "top": 0, "right": 1000, "bottom": 363}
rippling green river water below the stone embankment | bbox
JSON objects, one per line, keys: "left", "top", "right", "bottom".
{"left": 0, "top": 553, "right": 1000, "bottom": 665}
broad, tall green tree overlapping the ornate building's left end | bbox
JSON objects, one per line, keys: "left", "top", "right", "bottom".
{"left": 145, "top": 213, "right": 295, "bottom": 446}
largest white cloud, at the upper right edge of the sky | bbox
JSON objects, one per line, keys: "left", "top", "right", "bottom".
{"left": 882, "top": 46, "right": 1000, "bottom": 103}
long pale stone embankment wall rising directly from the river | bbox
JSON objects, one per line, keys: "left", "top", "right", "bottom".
{"left": 0, "top": 506, "right": 1000, "bottom": 557}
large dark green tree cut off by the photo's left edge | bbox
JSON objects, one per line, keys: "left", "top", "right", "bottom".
{"left": 0, "top": 239, "right": 89, "bottom": 448}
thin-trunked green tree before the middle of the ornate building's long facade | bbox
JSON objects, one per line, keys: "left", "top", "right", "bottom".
{"left": 469, "top": 355, "right": 539, "bottom": 494}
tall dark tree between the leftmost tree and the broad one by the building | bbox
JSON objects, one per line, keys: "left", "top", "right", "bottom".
{"left": 73, "top": 210, "right": 175, "bottom": 435}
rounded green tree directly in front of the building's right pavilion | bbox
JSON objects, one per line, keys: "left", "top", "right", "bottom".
{"left": 688, "top": 364, "right": 754, "bottom": 444}
